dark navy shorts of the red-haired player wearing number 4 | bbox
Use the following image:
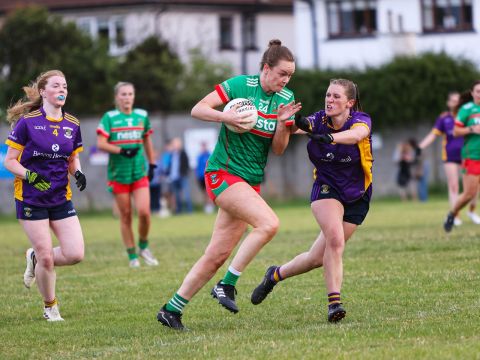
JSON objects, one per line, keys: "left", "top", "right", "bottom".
{"left": 15, "top": 199, "right": 77, "bottom": 220}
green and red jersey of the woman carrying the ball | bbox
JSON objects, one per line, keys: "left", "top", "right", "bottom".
{"left": 205, "top": 75, "right": 294, "bottom": 185}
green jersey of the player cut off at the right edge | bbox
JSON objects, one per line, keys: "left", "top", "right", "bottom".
{"left": 455, "top": 102, "right": 480, "bottom": 160}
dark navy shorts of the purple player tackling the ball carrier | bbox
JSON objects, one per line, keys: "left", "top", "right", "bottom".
{"left": 310, "top": 183, "right": 370, "bottom": 225}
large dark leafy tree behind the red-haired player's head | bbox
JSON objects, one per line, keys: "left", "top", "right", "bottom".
{"left": 0, "top": 6, "right": 116, "bottom": 114}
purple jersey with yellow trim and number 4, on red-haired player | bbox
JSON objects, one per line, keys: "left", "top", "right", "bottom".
{"left": 5, "top": 108, "right": 83, "bottom": 207}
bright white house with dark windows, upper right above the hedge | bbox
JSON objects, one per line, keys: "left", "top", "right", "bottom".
{"left": 294, "top": 0, "right": 480, "bottom": 69}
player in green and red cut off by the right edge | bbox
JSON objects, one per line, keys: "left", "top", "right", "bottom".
{"left": 443, "top": 80, "right": 480, "bottom": 232}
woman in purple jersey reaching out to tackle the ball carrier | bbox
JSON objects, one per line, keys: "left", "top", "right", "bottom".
{"left": 251, "top": 79, "right": 373, "bottom": 322}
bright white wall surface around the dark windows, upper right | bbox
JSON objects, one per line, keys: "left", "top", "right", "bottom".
{"left": 294, "top": 0, "right": 480, "bottom": 69}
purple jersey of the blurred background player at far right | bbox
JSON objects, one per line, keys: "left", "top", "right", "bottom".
{"left": 432, "top": 112, "right": 463, "bottom": 164}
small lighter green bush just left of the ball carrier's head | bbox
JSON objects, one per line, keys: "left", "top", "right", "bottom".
{"left": 175, "top": 49, "right": 233, "bottom": 110}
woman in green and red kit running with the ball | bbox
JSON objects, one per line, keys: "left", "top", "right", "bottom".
{"left": 157, "top": 40, "right": 301, "bottom": 329}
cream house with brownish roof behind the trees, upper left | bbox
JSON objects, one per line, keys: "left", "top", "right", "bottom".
{"left": 0, "top": 0, "right": 294, "bottom": 74}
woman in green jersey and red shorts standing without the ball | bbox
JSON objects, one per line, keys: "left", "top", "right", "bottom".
{"left": 97, "top": 82, "right": 158, "bottom": 268}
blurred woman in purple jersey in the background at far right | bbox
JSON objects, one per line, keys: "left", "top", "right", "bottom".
{"left": 419, "top": 91, "right": 480, "bottom": 226}
